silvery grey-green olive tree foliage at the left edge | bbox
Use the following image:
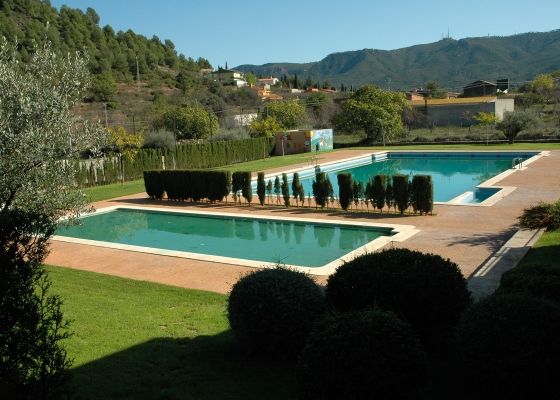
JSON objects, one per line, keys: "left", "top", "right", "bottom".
{"left": 0, "top": 36, "right": 106, "bottom": 225}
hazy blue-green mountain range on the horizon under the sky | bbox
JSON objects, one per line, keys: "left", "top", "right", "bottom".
{"left": 234, "top": 29, "right": 560, "bottom": 91}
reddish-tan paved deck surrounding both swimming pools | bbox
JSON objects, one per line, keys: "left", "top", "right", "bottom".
{"left": 46, "top": 150, "right": 560, "bottom": 295}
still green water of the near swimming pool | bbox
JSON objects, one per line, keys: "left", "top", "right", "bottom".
{"left": 56, "top": 209, "right": 392, "bottom": 268}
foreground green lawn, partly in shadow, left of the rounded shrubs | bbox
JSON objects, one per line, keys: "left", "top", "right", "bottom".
{"left": 47, "top": 266, "right": 295, "bottom": 400}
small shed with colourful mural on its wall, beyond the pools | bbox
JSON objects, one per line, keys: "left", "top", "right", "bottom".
{"left": 276, "top": 129, "right": 333, "bottom": 156}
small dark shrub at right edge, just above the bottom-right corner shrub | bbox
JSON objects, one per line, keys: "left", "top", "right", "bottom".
{"left": 498, "top": 262, "right": 560, "bottom": 302}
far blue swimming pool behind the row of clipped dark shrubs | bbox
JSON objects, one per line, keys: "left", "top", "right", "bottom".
{"left": 255, "top": 151, "right": 541, "bottom": 205}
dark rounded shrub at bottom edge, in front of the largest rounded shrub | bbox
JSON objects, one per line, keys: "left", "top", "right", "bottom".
{"left": 297, "top": 309, "right": 429, "bottom": 400}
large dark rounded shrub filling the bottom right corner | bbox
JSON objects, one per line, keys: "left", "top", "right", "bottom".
{"left": 456, "top": 293, "right": 560, "bottom": 399}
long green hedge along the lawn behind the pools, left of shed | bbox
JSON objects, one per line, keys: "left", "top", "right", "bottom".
{"left": 75, "top": 138, "right": 275, "bottom": 187}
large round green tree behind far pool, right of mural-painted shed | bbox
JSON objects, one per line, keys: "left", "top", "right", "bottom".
{"left": 333, "top": 85, "right": 410, "bottom": 140}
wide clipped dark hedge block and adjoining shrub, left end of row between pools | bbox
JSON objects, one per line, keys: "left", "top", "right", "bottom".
{"left": 144, "top": 170, "right": 247, "bottom": 203}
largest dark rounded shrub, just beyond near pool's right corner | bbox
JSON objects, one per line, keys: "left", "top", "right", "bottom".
{"left": 327, "top": 249, "right": 472, "bottom": 341}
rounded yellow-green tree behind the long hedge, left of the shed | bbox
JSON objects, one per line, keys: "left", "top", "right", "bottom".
{"left": 154, "top": 106, "right": 219, "bottom": 139}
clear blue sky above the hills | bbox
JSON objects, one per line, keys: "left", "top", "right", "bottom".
{"left": 51, "top": 0, "right": 560, "bottom": 68}
